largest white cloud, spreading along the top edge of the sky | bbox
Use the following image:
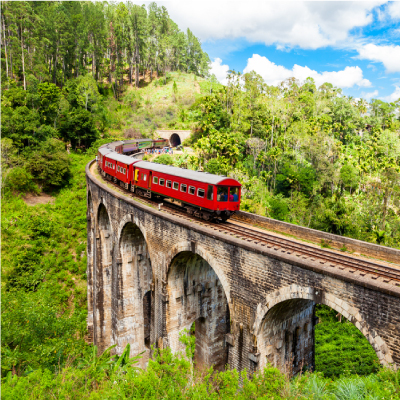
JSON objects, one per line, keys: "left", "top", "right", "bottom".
{"left": 160, "top": 0, "right": 384, "bottom": 49}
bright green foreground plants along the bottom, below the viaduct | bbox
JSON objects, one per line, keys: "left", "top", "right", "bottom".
{"left": 2, "top": 345, "right": 400, "bottom": 400}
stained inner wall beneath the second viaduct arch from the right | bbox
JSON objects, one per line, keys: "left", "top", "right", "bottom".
{"left": 166, "top": 249, "right": 230, "bottom": 370}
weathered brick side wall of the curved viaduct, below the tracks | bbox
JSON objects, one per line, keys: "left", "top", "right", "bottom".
{"left": 86, "top": 161, "right": 400, "bottom": 371}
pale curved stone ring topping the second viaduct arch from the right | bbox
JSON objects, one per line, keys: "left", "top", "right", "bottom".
{"left": 165, "top": 241, "right": 231, "bottom": 304}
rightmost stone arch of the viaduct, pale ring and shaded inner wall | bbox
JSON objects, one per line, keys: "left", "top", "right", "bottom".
{"left": 253, "top": 285, "right": 393, "bottom": 373}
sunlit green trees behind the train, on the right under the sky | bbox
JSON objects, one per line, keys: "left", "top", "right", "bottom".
{"left": 190, "top": 71, "right": 400, "bottom": 247}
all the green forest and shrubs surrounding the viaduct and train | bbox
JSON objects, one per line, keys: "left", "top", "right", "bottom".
{"left": 1, "top": 2, "right": 400, "bottom": 399}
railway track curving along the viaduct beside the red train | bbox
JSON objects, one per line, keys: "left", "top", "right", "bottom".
{"left": 102, "top": 173, "right": 400, "bottom": 287}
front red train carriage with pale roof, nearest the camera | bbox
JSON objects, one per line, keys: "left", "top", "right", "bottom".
{"left": 132, "top": 161, "right": 241, "bottom": 221}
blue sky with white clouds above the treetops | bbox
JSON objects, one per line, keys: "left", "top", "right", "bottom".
{"left": 151, "top": 0, "right": 400, "bottom": 101}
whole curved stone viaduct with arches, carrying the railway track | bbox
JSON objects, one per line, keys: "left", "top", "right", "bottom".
{"left": 86, "top": 162, "right": 400, "bottom": 373}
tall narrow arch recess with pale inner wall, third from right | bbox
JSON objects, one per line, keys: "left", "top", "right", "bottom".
{"left": 113, "top": 222, "right": 153, "bottom": 367}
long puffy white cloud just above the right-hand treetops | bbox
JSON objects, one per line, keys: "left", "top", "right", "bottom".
{"left": 243, "top": 54, "right": 371, "bottom": 88}
